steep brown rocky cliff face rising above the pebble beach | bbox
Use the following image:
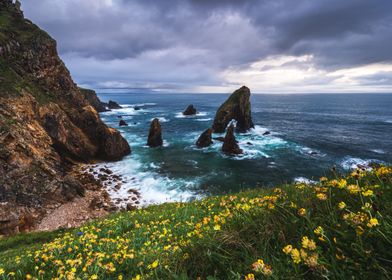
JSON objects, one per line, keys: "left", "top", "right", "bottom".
{"left": 0, "top": 0, "right": 130, "bottom": 234}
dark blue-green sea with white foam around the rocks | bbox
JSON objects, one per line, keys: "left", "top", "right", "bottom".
{"left": 95, "top": 93, "right": 392, "bottom": 203}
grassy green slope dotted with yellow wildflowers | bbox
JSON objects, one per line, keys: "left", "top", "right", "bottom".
{"left": 0, "top": 167, "right": 392, "bottom": 279}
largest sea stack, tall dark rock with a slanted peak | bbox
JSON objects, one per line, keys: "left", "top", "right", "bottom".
{"left": 212, "top": 86, "right": 254, "bottom": 133}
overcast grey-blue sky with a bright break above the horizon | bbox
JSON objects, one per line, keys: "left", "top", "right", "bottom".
{"left": 22, "top": 0, "right": 392, "bottom": 93}
